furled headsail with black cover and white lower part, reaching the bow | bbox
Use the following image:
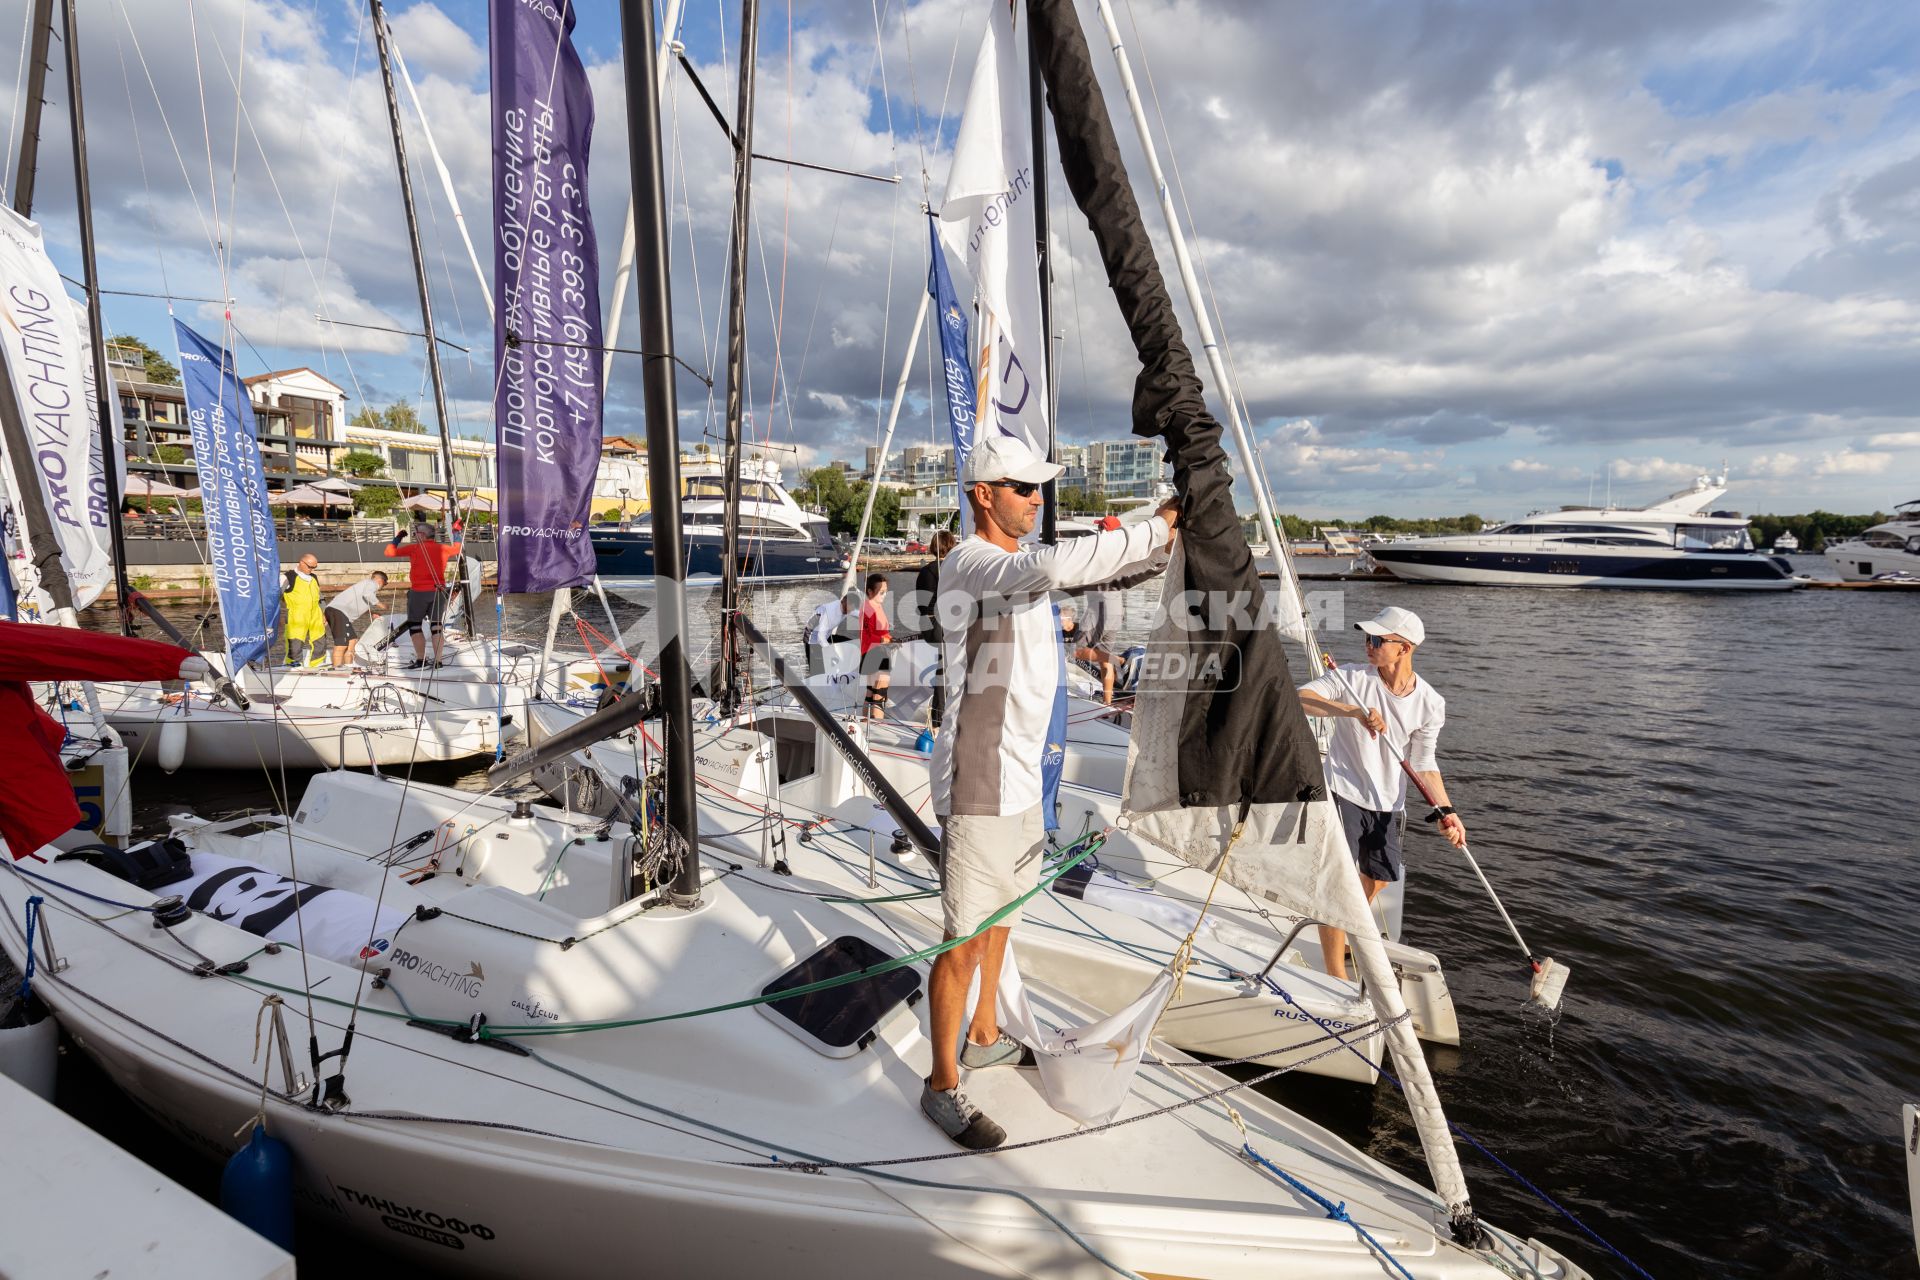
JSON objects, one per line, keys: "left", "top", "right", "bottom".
{"left": 1029, "top": 0, "right": 1478, "bottom": 1242}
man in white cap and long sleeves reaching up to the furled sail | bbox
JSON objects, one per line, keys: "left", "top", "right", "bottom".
{"left": 920, "top": 436, "right": 1181, "bottom": 1150}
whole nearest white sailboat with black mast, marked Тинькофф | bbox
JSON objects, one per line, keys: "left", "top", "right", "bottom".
{"left": 0, "top": 0, "right": 1584, "bottom": 1280}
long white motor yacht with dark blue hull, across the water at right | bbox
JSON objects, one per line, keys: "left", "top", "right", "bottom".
{"left": 1369, "top": 476, "right": 1797, "bottom": 591}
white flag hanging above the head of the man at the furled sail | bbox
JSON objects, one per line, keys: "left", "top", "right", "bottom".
{"left": 941, "top": 0, "right": 1048, "bottom": 457}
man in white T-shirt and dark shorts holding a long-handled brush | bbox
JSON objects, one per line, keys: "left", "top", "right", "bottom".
{"left": 1300, "top": 604, "right": 1467, "bottom": 979}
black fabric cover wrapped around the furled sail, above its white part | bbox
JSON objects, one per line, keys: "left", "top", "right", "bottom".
{"left": 1027, "top": 0, "right": 1327, "bottom": 808}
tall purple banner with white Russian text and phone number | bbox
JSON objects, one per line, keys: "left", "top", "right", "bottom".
{"left": 490, "top": 0, "right": 603, "bottom": 593}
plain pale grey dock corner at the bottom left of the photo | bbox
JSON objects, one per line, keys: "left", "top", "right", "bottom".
{"left": 0, "top": 1075, "right": 294, "bottom": 1280}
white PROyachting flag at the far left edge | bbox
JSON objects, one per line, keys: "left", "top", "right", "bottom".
{"left": 0, "top": 209, "right": 125, "bottom": 608}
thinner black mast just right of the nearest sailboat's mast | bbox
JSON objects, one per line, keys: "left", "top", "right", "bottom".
{"left": 718, "top": 0, "right": 760, "bottom": 712}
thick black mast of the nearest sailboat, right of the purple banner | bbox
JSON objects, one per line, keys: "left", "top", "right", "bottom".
{"left": 620, "top": 0, "right": 701, "bottom": 908}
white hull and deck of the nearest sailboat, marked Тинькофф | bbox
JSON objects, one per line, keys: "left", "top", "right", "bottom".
{"left": 0, "top": 773, "right": 1582, "bottom": 1280}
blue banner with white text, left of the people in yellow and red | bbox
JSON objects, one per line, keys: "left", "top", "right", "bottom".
{"left": 173, "top": 320, "right": 280, "bottom": 670}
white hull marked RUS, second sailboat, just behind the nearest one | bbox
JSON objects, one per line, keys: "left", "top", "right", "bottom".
{"left": 528, "top": 700, "right": 1459, "bottom": 1084}
